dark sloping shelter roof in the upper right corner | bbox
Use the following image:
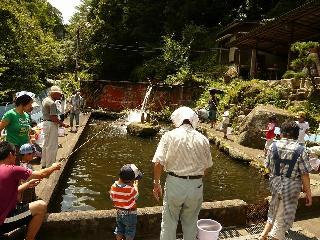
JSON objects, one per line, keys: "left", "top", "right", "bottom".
{"left": 229, "top": 0, "right": 320, "bottom": 54}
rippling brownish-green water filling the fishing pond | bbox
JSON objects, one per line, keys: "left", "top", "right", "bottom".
{"left": 53, "top": 120, "right": 268, "bottom": 212}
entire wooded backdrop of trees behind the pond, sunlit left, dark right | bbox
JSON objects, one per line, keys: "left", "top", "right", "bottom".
{"left": 0, "top": 0, "right": 306, "bottom": 101}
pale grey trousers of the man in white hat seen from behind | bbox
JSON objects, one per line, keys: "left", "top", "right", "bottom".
{"left": 160, "top": 175, "right": 203, "bottom": 240}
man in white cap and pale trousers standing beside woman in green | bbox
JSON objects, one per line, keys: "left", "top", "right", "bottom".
{"left": 41, "top": 86, "right": 69, "bottom": 168}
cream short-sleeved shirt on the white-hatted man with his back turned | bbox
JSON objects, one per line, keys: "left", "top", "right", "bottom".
{"left": 152, "top": 124, "right": 213, "bottom": 176}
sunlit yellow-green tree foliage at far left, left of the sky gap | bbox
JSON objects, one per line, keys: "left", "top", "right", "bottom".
{"left": 0, "top": 0, "right": 63, "bottom": 100}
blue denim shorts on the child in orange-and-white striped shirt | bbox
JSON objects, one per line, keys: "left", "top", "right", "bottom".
{"left": 114, "top": 212, "right": 137, "bottom": 240}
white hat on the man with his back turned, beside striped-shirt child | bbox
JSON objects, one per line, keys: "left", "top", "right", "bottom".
{"left": 171, "top": 106, "right": 199, "bottom": 128}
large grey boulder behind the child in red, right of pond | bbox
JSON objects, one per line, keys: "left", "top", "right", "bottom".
{"left": 237, "top": 105, "right": 294, "bottom": 149}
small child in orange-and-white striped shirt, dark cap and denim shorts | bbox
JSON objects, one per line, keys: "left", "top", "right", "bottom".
{"left": 110, "top": 164, "right": 142, "bottom": 240}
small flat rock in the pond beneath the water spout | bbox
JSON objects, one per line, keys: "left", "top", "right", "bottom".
{"left": 127, "top": 122, "right": 160, "bottom": 137}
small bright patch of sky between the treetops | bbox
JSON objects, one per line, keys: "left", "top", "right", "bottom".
{"left": 48, "top": 0, "right": 81, "bottom": 23}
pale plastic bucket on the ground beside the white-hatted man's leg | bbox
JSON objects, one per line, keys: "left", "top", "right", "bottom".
{"left": 197, "top": 219, "right": 222, "bottom": 240}
